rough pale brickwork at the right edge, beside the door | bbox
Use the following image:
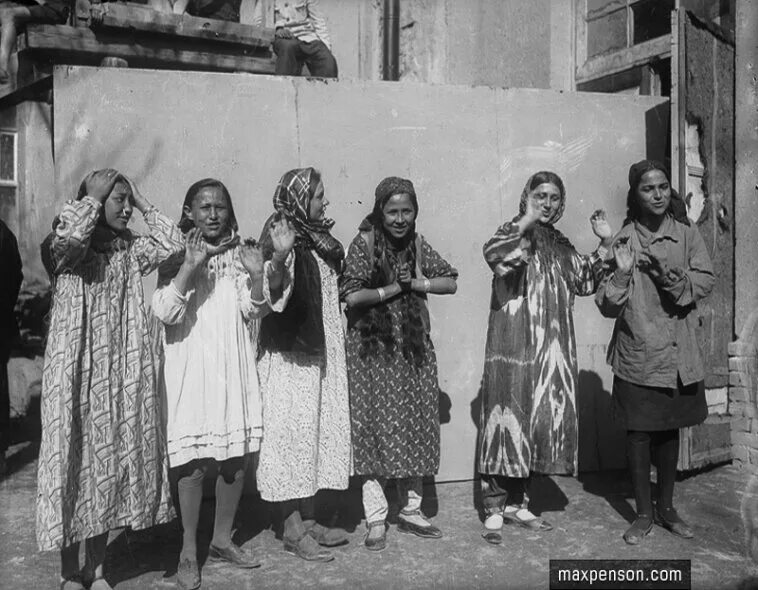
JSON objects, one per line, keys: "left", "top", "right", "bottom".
{"left": 729, "top": 312, "right": 758, "bottom": 467}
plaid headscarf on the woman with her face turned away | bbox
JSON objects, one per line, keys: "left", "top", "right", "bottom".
{"left": 274, "top": 167, "right": 345, "bottom": 268}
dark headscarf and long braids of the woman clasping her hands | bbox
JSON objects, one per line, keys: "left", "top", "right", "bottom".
{"left": 349, "top": 176, "right": 429, "bottom": 367}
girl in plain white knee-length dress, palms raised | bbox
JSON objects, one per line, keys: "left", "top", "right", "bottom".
{"left": 152, "top": 178, "right": 295, "bottom": 590}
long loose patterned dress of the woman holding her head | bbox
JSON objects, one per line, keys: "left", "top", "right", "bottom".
{"left": 37, "top": 197, "right": 184, "bottom": 551}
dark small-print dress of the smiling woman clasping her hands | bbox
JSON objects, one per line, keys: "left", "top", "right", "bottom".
{"left": 340, "top": 234, "right": 458, "bottom": 478}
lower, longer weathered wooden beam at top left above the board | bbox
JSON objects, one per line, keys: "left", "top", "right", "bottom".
{"left": 23, "top": 25, "right": 274, "bottom": 74}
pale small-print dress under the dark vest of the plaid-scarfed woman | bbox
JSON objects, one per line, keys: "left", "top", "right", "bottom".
{"left": 256, "top": 251, "right": 351, "bottom": 502}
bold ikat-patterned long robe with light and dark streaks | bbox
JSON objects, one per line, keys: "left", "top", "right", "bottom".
{"left": 479, "top": 222, "right": 605, "bottom": 477}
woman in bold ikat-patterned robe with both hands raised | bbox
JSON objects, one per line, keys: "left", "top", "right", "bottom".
{"left": 478, "top": 171, "right": 613, "bottom": 544}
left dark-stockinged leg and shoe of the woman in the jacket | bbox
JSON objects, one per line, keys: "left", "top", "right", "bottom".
{"left": 624, "top": 430, "right": 653, "bottom": 545}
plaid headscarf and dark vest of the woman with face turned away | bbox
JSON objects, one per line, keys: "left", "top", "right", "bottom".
{"left": 259, "top": 168, "right": 345, "bottom": 360}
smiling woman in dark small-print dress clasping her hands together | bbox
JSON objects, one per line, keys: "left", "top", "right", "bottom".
{"left": 340, "top": 177, "right": 458, "bottom": 551}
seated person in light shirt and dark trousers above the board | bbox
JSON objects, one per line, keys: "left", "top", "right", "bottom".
{"left": 253, "top": 0, "right": 337, "bottom": 78}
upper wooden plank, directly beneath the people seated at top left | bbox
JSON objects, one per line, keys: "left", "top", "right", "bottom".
{"left": 91, "top": 2, "right": 274, "bottom": 49}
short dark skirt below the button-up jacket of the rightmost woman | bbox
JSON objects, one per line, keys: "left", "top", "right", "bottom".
{"left": 613, "top": 377, "right": 708, "bottom": 431}
